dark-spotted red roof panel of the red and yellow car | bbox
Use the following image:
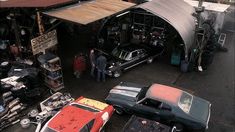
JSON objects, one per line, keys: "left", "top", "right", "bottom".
{"left": 48, "top": 105, "right": 96, "bottom": 132}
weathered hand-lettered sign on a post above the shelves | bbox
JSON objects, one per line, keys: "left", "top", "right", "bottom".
{"left": 31, "top": 30, "right": 58, "bottom": 55}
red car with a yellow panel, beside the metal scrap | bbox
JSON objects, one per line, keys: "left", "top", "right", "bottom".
{"left": 41, "top": 97, "right": 114, "bottom": 132}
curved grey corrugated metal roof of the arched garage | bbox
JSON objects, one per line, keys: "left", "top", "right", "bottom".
{"left": 136, "top": 0, "right": 196, "bottom": 56}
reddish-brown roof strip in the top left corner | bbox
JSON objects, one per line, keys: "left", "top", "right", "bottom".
{"left": 0, "top": 0, "right": 75, "bottom": 8}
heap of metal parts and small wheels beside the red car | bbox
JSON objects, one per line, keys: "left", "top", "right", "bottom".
{"left": 20, "top": 92, "right": 74, "bottom": 132}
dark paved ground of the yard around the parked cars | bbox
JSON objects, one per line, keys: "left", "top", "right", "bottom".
{"left": 4, "top": 5, "right": 235, "bottom": 132}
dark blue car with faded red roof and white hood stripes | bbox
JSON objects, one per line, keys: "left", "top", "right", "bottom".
{"left": 106, "top": 83, "right": 211, "bottom": 131}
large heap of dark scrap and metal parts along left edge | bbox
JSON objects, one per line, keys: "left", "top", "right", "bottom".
{"left": 0, "top": 62, "right": 42, "bottom": 131}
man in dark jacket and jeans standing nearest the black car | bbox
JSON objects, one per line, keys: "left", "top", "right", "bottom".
{"left": 96, "top": 53, "right": 107, "bottom": 82}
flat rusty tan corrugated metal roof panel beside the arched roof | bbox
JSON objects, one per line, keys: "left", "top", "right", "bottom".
{"left": 43, "top": 0, "right": 135, "bottom": 25}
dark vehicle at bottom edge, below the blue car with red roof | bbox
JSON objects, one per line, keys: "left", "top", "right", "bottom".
{"left": 123, "top": 115, "right": 176, "bottom": 132}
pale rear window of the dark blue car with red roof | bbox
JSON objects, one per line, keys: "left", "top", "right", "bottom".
{"left": 178, "top": 92, "right": 193, "bottom": 114}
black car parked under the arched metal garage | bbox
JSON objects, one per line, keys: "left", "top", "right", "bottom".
{"left": 107, "top": 44, "right": 162, "bottom": 77}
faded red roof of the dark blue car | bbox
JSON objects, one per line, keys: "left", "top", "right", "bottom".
{"left": 146, "top": 84, "right": 183, "bottom": 105}
